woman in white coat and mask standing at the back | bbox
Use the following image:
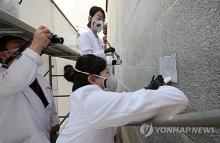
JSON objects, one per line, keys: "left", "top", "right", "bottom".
{"left": 79, "top": 6, "right": 115, "bottom": 62}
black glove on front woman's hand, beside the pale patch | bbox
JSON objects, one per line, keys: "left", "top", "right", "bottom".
{"left": 145, "top": 75, "right": 165, "bottom": 90}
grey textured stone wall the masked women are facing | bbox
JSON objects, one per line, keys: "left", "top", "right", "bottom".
{"left": 108, "top": 0, "right": 220, "bottom": 143}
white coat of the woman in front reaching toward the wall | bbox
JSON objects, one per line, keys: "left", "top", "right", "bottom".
{"left": 57, "top": 85, "right": 188, "bottom": 143}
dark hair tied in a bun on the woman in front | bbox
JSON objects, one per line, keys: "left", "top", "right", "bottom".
{"left": 64, "top": 54, "right": 106, "bottom": 91}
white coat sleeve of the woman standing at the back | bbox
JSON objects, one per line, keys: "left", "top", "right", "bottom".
{"left": 80, "top": 33, "right": 106, "bottom": 58}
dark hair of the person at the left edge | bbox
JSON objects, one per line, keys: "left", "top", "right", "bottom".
{"left": 0, "top": 35, "right": 25, "bottom": 51}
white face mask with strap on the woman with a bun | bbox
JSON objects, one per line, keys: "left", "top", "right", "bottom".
{"left": 74, "top": 68, "right": 117, "bottom": 92}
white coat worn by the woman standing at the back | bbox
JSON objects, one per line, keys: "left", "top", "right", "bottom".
{"left": 79, "top": 29, "right": 106, "bottom": 60}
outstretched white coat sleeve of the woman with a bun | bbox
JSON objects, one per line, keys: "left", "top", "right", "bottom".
{"left": 88, "top": 86, "right": 188, "bottom": 129}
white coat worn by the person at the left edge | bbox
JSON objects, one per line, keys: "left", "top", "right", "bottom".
{"left": 0, "top": 48, "right": 59, "bottom": 143}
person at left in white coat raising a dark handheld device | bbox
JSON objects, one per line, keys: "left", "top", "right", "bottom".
{"left": 0, "top": 26, "right": 59, "bottom": 143}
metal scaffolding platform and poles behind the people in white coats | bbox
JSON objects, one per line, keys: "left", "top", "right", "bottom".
{"left": 0, "top": 6, "right": 80, "bottom": 124}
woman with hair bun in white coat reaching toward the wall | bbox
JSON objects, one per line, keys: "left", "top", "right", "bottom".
{"left": 57, "top": 54, "right": 188, "bottom": 143}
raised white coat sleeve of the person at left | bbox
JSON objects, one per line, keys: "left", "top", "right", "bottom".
{"left": 0, "top": 48, "right": 43, "bottom": 97}
